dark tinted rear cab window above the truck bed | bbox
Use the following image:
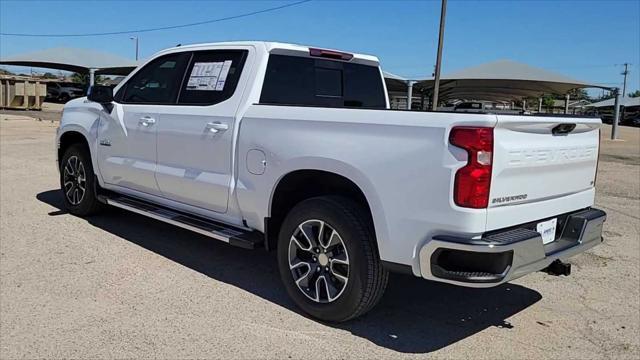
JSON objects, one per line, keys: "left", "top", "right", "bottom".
{"left": 260, "top": 54, "right": 386, "bottom": 109}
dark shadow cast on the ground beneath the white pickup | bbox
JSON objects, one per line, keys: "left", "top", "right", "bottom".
{"left": 36, "top": 190, "right": 541, "bottom": 353}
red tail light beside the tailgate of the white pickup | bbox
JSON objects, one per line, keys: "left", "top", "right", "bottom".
{"left": 449, "top": 127, "right": 493, "bottom": 209}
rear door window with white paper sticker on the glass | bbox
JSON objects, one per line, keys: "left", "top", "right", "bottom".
{"left": 178, "top": 50, "right": 248, "bottom": 105}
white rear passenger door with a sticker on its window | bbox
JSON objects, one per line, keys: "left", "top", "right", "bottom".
{"left": 156, "top": 47, "right": 251, "bottom": 213}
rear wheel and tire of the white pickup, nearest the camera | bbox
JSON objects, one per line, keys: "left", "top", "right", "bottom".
{"left": 277, "top": 196, "right": 388, "bottom": 322}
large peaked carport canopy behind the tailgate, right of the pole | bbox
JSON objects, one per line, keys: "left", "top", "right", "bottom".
{"left": 415, "top": 60, "right": 603, "bottom": 101}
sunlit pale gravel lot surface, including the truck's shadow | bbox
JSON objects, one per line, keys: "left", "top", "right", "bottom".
{"left": 0, "top": 108, "right": 640, "bottom": 359}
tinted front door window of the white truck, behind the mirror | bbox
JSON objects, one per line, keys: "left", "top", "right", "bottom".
{"left": 116, "top": 53, "right": 191, "bottom": 104}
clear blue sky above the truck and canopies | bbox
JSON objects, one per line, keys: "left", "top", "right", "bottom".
{"left": 0, "top": 0, "right": 640, "bottom": 92}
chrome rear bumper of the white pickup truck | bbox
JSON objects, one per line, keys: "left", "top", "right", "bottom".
{"left": 420, "top": 208, "right": 607, "bottom": 287}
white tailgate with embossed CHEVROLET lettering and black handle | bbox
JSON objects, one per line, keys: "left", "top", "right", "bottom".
{"left": 487, "top": 115, "right": 601, "bottom": 230}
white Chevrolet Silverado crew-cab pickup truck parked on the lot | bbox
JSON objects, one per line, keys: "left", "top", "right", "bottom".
{"left": 56, "top": 42, "right": 606, "bottom": 321}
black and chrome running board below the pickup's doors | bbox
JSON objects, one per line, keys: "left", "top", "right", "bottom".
{"left": 105, "top": 196, "right": 264, "bottom": 249}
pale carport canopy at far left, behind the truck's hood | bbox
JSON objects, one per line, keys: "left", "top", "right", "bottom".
{"left": 0, "top": 48, "right": 137, "bottom": 75}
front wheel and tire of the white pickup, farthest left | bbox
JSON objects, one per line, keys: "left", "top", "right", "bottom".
{"left": 60, "top": 144, "right": 104, "bottom": 216}
